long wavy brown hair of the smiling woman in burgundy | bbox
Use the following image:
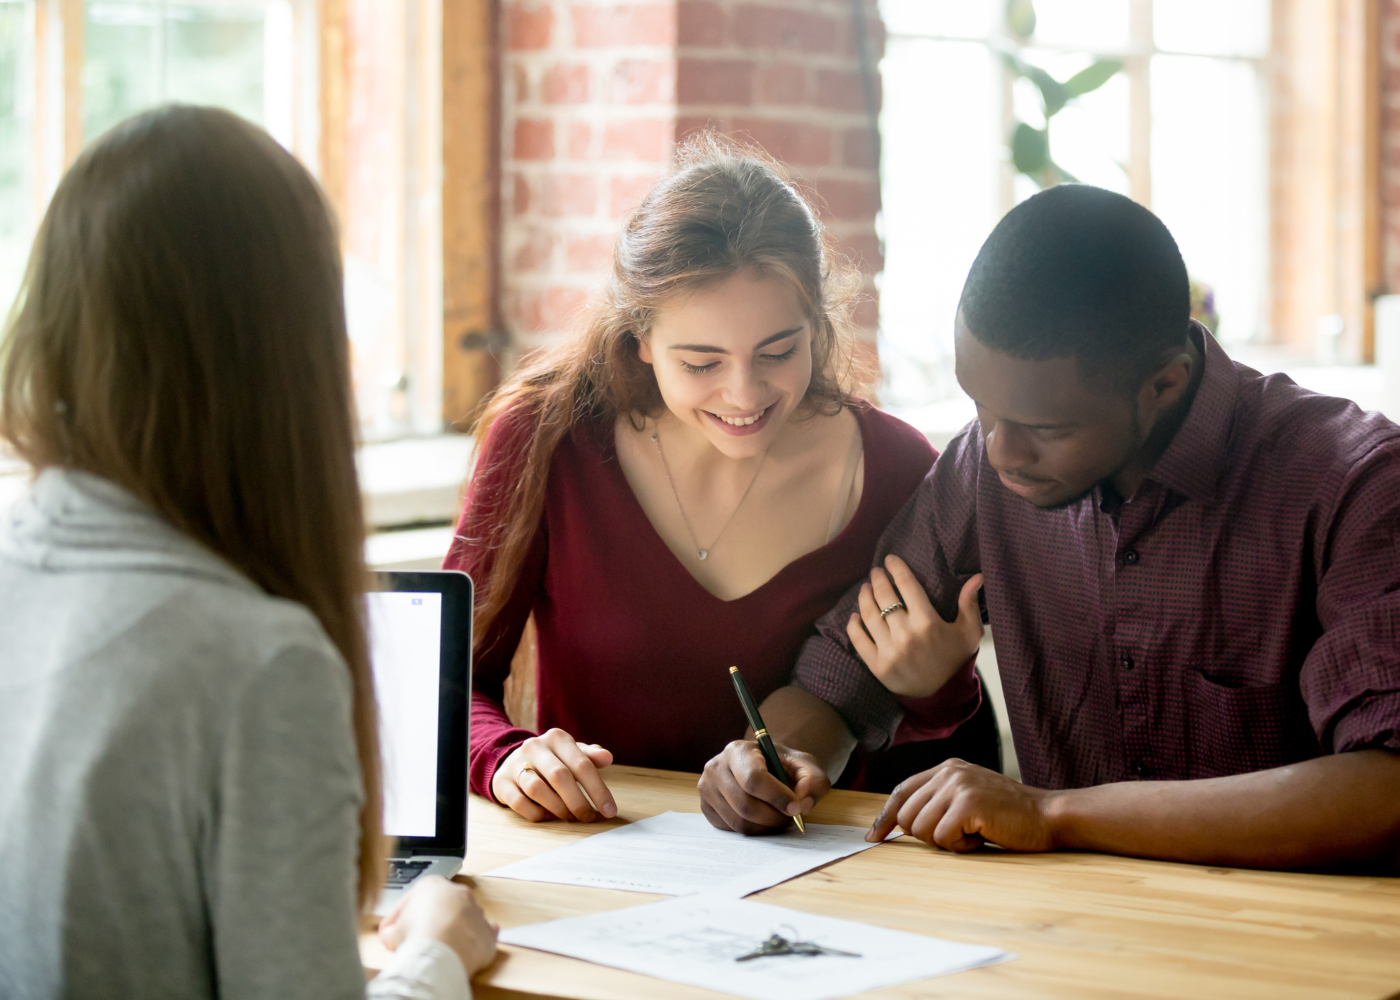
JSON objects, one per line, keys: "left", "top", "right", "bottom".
{"left": 462, "top": 136, "right": 869, "bottom": 644}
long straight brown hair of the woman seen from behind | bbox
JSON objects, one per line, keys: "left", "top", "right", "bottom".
{"left": 0, "top": 106, "right": 385, "bottom": 903}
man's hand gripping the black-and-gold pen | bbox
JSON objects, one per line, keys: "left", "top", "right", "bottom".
{"left": 700, "top": 739, "right": 832, "bottom": 835}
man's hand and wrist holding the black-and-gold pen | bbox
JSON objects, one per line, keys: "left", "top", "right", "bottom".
{"left": 700, "top": 686, "right": 855, "bottom": 833}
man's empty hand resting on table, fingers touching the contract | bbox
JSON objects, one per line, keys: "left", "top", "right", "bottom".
{"left": 865, "top": 759, "right": 1057, "bottom": 852}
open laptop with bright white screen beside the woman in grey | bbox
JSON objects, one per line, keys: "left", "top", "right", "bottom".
{"left": 367, "top": 571, "right": 472, "bottom": 916}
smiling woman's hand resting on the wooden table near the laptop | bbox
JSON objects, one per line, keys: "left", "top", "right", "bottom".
{"left": 491, "top": 730, "right": 617, "bottom": 824}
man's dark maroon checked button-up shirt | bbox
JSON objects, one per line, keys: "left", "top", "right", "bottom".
{"left": 794, "top": 328, "right": 1400, "bottom": 789}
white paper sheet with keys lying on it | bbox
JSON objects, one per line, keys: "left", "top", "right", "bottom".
{"left": 500, "top": 896, "right": 1014, "bottom": 1000}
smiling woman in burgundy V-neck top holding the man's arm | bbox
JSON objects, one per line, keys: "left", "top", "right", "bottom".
{"left": 445, "top": 139, "right": 995, "bottom": 829}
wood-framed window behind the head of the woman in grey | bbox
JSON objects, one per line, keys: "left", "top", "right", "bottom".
{"left": 0, "top": 0, "right": 481, "bottom": 436}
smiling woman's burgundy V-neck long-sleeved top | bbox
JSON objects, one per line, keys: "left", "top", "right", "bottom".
{"left": 444, "top": 405, "right": 968, "bottom": 796}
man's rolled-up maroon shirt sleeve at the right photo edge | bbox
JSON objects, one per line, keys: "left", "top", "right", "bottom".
{"left": 1299, "top": 441, "right": 1400, "bottom": 754}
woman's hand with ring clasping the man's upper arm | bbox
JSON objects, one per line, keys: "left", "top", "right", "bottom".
{"left": 846, "top": 556, "right": 983, "bottom": 697}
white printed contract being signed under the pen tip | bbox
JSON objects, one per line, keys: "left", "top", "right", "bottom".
{"left": 484, "top": 812, "right": 875, "bottom": 896}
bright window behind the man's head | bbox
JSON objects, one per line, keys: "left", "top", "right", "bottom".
{"left": 881, "top": 0, "right": 1270, "bottom": 408}
